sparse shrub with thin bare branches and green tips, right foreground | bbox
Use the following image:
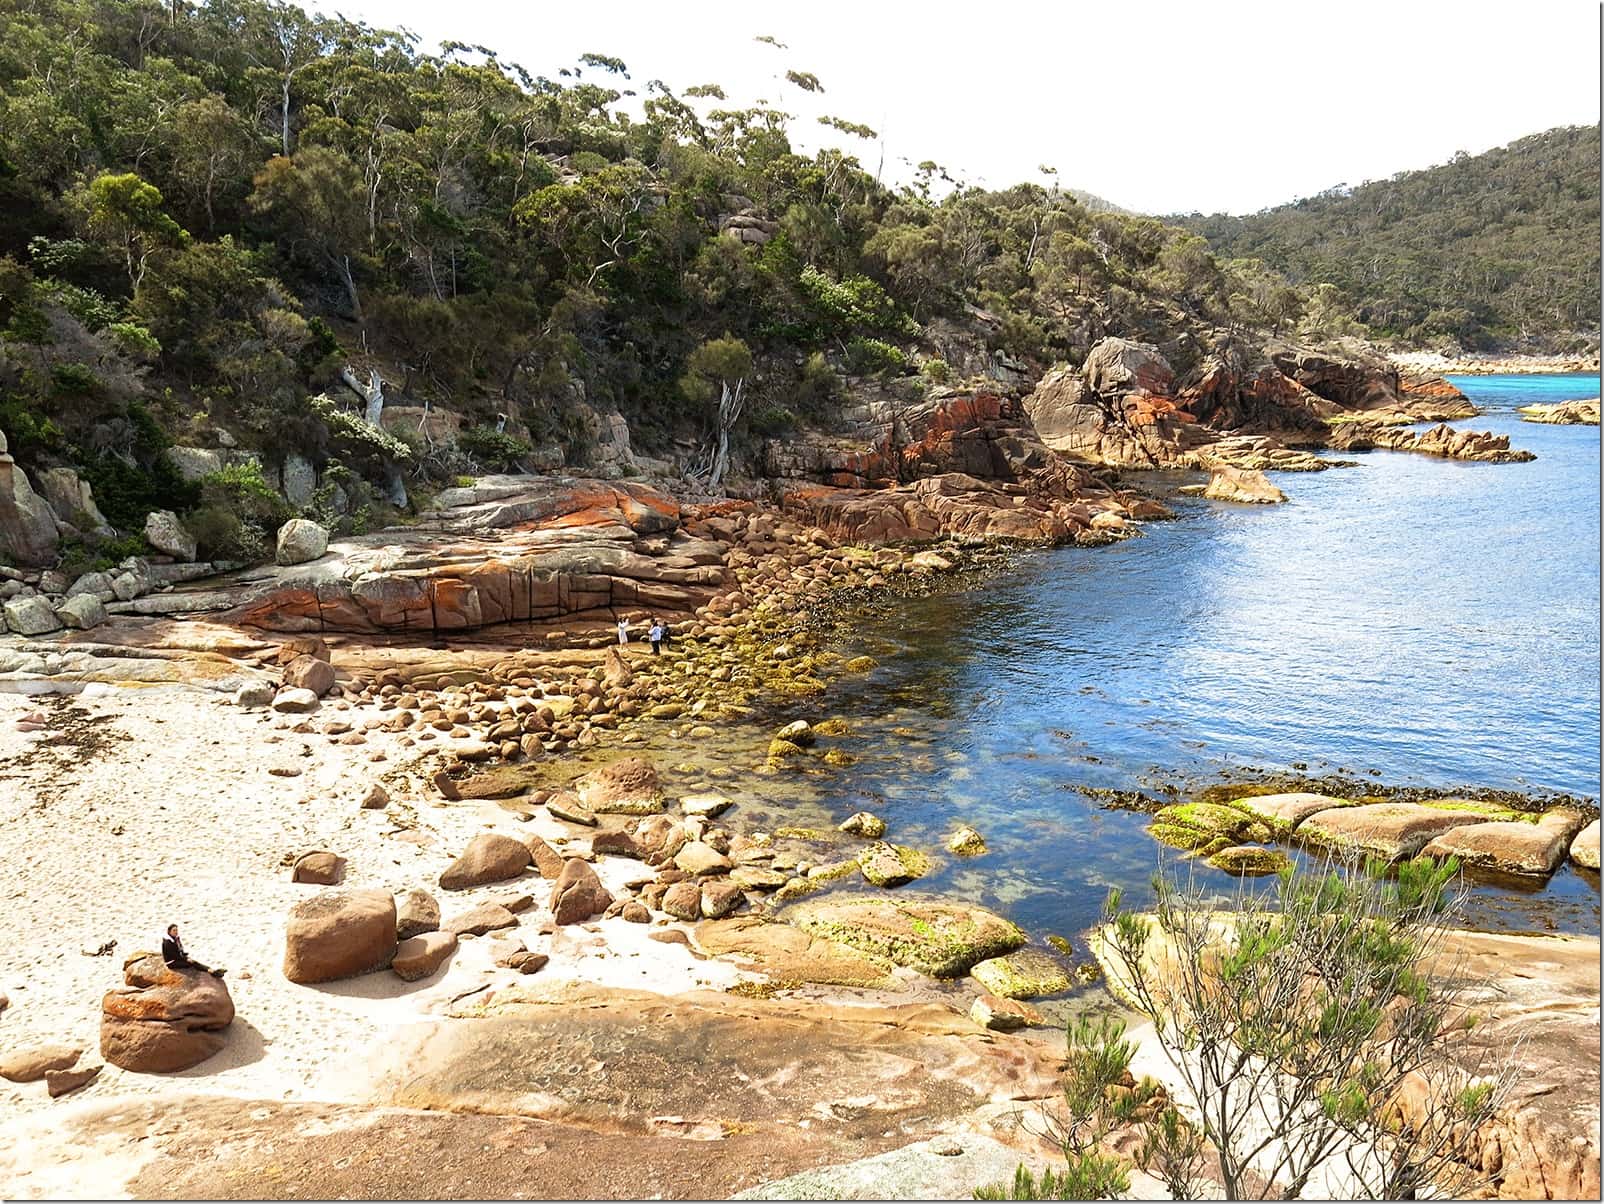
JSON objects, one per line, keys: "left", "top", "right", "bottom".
{"left": 1102, "top": 859, "right": 1514, "bottom": 1199}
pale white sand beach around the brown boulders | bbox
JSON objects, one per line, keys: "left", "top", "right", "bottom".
{"left": 0, "top": 688, "right": 741, "bottom": 1135}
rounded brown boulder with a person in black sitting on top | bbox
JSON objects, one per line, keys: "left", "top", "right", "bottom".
{"left": 101, "top": 952, "right": 234, "bottom": 1074}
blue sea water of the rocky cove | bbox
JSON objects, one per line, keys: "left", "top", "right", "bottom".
{"left": 808, "top": 377, "right": 1599, "bottom": 931}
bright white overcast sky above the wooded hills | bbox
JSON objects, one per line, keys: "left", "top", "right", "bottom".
{"left": 303, "top": 0, "right": 1599, "bottom": 213}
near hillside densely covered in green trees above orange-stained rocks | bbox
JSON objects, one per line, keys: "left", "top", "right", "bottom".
{"left": 0, "top": 0, "right": 1417, "bottom": 570}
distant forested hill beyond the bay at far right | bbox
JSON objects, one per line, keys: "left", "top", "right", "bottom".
{"left": 1181, "top": 125, "right": 1599, "bottom": 351}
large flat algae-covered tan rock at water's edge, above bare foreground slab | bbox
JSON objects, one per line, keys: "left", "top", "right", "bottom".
{"left": 781, "top": 895, "right": 1025, "bottom": 978}
